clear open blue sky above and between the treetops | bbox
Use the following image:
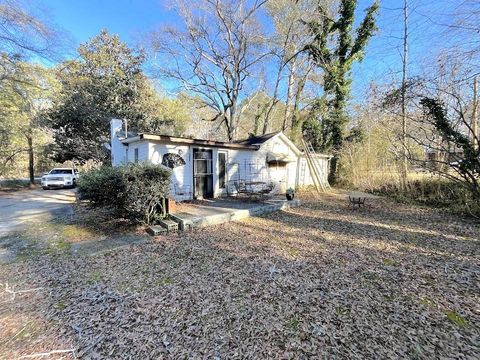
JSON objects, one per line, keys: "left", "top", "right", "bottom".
{"left": 37, "top": 0, "right": 468, "bottom": 100}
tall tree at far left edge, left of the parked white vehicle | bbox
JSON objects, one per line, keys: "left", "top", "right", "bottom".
{"left": 0, "top": 0, "right": 66, "bottom": 184}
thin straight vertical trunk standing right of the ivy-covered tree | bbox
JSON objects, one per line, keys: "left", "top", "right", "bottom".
{"left": 400, "top": 0, "right": 408, "bottom": 190}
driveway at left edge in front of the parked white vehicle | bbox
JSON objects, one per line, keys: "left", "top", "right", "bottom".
{"left": 0, "top": 189, "right": 75, "bottom": 237}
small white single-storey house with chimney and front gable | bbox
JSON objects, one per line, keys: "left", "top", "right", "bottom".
{"left": 110, "top": 119, "right": 330, "bottom": 201}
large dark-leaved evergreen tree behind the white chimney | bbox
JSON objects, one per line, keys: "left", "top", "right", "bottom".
{"left": 48, "top": 31, "right": 173, "bottom": 163}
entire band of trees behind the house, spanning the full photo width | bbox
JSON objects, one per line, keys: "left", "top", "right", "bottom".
{"left": 0, "top": 0, "right": 478, "bottom": 207}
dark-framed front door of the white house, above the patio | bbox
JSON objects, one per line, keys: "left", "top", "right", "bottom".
{"left": 193, "top": 149, "right": 213, "bottom": 199}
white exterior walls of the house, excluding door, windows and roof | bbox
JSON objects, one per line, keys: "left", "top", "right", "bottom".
{"left": 111, "top": 119, "right": 328, "bottom": 201}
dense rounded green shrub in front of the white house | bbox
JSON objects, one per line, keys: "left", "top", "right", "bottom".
{"left": 78, "top": 163, "right": 170, "bottom": 224}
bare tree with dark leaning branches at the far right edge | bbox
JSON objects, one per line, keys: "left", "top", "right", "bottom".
{"left": 384, "top": 57, "right": 480, "bottom": 199}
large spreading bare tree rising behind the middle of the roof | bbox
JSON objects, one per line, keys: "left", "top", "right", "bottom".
{"left": 150, "top": 0, "right": 270, "bottom": 141}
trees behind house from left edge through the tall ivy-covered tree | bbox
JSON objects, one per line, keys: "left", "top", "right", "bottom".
{"left": 0, "top": 0, "right": 378, "bottom": 183}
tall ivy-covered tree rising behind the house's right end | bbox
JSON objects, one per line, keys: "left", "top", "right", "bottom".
{"left": 304, "top": 0, "right": 379, "bottom": 182}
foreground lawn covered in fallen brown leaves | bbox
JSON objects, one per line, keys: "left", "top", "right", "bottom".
{"left": 0, "top": 196, "right": 480, "bottom": 359}
